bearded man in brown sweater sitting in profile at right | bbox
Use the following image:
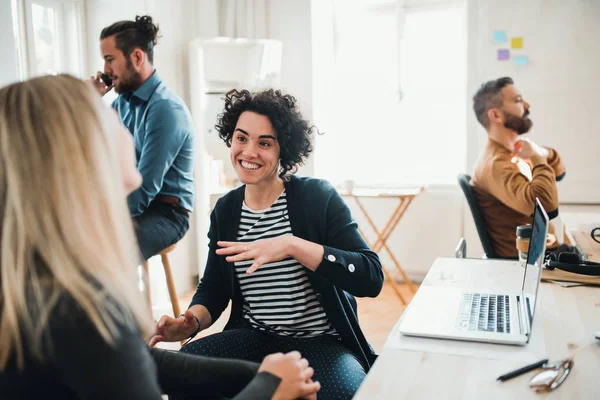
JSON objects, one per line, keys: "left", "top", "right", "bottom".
{"left": 472, "top": 77, "right": 565, "bottom": 258}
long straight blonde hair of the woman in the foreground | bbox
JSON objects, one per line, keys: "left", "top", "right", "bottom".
{"left": 0, "top": 75, "right": 151, "bottom": 371}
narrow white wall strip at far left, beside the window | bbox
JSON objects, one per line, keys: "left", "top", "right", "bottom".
{"left": 0, "top": 0, "right": 19, "bottom": 87}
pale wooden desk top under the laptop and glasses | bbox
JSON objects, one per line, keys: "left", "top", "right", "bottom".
{"left": 355, "top": 258, "right": 600, "bottom": 400}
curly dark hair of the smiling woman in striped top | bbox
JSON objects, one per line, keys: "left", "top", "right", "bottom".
{"left": 215, "top": 89, "right": 318, "bottom": 179}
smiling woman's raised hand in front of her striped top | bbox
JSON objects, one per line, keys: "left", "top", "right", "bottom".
{"left": 217, "top": 235, "right": 295, "bottom": 274}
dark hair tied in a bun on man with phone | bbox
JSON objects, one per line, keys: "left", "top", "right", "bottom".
{"left": 100, "top": 15, "right": 158, "bottom": 63}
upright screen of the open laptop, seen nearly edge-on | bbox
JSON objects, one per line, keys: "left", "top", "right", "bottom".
{"left": 522, "top": 198, "right": 548, "bottom": 322}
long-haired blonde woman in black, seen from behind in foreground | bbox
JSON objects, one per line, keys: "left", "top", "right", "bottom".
{"left": 0, "top": 75, "right": 319, "bottom": 400}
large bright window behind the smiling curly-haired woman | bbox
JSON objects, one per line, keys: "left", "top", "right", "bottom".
{"left": 315, "top": 0, "right": 467, "bottom": 186}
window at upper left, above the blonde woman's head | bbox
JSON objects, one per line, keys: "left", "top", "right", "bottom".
{"left": 16, "top": 0, "right": 83, "bottom": 78}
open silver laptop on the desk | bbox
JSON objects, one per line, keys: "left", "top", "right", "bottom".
{"left": 399, "top": 198, "right": 548, "bottom": 346}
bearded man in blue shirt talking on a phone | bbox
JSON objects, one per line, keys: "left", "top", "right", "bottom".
{"left": 90, "top": 16, "right": 194, "bottom": 260}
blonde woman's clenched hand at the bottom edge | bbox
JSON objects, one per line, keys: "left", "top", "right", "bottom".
{"left": 258, "top": 351, "right": 321, "bottom": 400}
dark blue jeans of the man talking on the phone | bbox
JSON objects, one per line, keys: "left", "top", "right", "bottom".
{"left": 133, "top": 201, "right": 189, "bottom": 260}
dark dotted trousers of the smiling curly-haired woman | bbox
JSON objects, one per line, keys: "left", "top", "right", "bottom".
{"left": 173, "top": 328, "right": 366, "bottom": 400}
